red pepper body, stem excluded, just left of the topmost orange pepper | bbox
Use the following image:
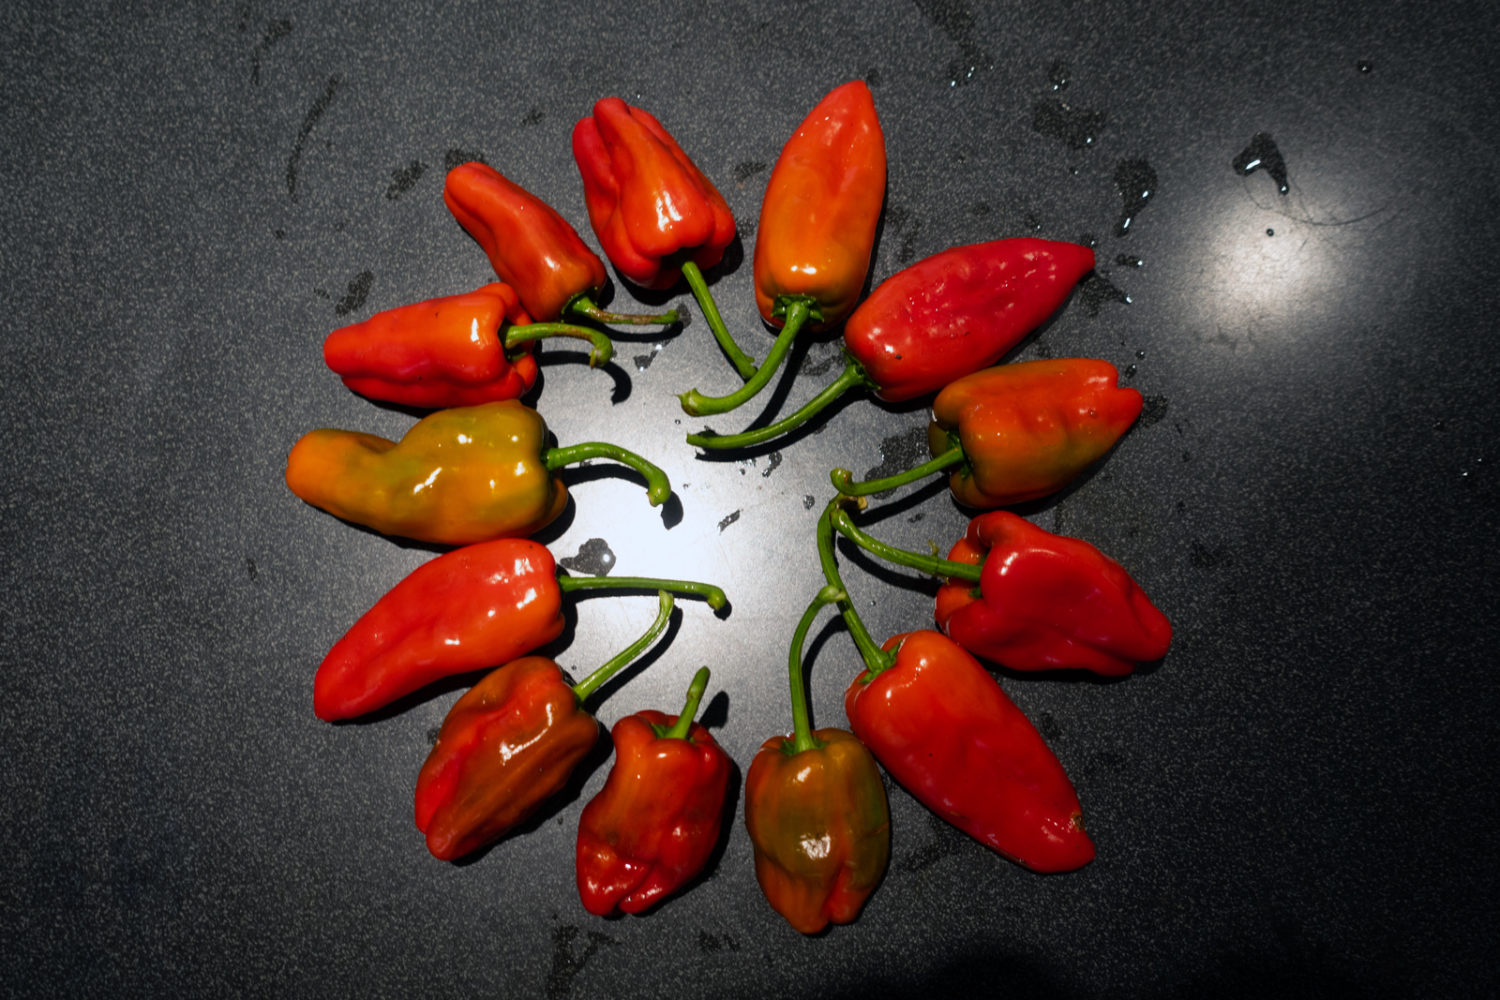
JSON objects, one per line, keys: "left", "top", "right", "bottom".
{"left": 573, "top": 97, "right": 735, "bottom": 288}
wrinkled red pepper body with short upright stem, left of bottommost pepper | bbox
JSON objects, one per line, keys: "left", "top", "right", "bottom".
{"left": 578, "top": 709, "right": 731, "bottom": 916}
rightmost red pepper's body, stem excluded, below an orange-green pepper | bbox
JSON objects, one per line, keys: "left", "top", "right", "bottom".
{"left": 936, "top": 510, "right": 1172, "bottom": 676}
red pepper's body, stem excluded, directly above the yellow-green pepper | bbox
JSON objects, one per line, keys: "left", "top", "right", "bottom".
{"left": 323, "top": 282, "right": 537, "bottom": 409}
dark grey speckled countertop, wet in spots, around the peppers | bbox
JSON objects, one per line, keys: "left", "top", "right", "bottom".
{"left": 0, "top": 0, "right": 1500, "bottom": 999}
